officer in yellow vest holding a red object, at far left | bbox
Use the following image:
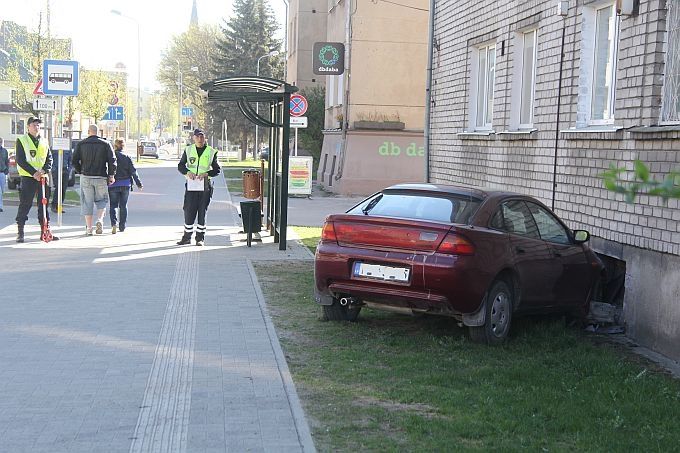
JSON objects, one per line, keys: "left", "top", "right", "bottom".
{"left": 16, "top": 116, "right": 59, "bottom": 242}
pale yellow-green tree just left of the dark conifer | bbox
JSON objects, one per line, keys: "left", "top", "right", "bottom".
{"left": 157, "top": 25, "right": 220, "bottom": 139}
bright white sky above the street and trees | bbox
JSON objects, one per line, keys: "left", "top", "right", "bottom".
{"left": 0, "top": 0, "right": 285, "bottom": 90}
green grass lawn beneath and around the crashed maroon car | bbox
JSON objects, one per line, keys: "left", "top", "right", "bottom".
{"left": 254, "top": 260, "right": 680, "bottom": 452}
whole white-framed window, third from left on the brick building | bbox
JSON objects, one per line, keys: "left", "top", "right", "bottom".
{"left": 576, "top": 1, "right": 619, "bottom": 127}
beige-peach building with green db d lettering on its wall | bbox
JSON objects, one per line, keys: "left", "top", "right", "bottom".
{"left": 317, "top": 0, "right": 429, "bottom": 194}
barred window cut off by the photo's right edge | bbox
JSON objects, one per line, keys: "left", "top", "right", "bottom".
{"left": 661, "top": 0, "right": 680, "bottom": 123}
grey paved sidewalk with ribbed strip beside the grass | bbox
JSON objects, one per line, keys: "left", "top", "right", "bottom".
{"left": 0, "top": 170, "right": 364, "bottom": 452}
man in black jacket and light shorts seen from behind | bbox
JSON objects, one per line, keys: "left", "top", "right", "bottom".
{"left": 73, "top": 124, "right": 116, "bottom": 236}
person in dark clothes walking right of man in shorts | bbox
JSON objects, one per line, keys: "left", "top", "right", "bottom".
{"left": 109, "top": 139, "right": 144, "bottom": 234}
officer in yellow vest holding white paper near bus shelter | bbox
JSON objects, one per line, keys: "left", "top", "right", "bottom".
{"left": 177, "top": 129, "right": 220, "bottom": 246}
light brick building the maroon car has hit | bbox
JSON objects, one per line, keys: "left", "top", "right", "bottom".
{"left": 428, "top": 0, "right": 680, "bottom": 360}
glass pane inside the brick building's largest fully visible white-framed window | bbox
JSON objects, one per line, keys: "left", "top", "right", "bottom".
{"left": 590, "top": 5, "right": 618, "bottom": 121}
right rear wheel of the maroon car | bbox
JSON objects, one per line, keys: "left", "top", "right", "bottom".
{"left": 469, "top": 280, "right": 513, "bottom": 345}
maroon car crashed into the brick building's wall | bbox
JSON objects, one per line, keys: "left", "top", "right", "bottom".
{"left": 314, "top": 184, "right": 603, "bottom": 343}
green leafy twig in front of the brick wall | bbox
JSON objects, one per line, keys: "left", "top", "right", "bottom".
{"left": 602, "top": 160, "right": 680, "bottom": 203}
